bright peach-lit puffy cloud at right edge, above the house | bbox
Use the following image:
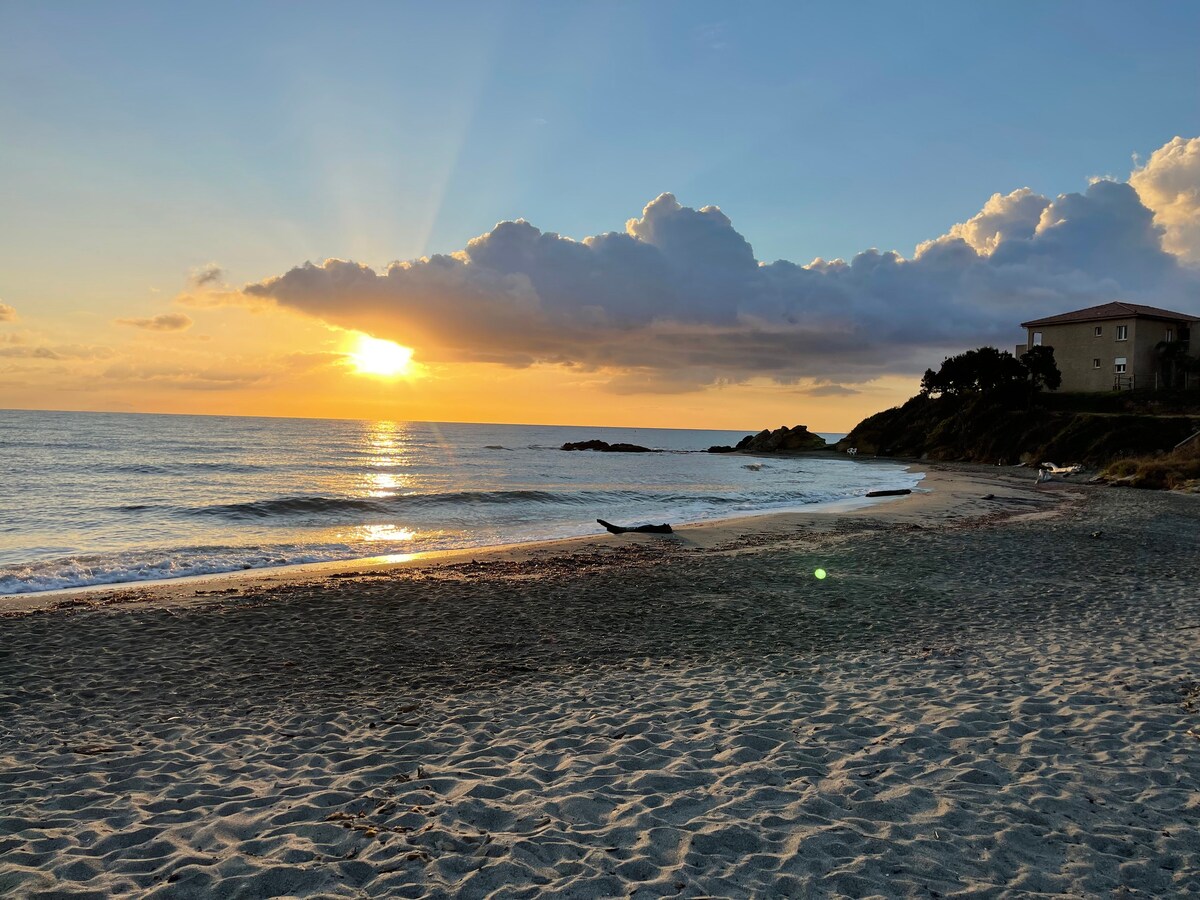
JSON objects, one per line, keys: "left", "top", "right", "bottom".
{"left": 1129, "top": 137, "right": 1200, "bottom": 265}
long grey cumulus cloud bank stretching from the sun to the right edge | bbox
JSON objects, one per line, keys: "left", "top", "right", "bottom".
{"left": 244, "top": 137, "right": 1200, "bottom": 392}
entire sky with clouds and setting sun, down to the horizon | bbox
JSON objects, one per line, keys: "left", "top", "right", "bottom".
{"left": 0, "top": 0, "right": 1200, "bottom": 431}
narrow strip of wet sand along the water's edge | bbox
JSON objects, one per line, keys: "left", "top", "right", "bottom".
{"left": 0, "top": 465, "right": 1073, "bottom": 618}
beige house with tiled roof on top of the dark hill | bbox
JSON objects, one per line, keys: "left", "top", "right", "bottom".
{"left": 1016, "top": 302, "right": 1200, "bottom": 391}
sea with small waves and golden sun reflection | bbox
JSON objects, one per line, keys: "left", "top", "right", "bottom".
{"left": 0, "top": 410, "right": 919, "bottom": 594}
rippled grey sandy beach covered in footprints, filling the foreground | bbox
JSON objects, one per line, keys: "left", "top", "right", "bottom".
{"left": 0, "top": 469, "right": 1200, "bottom": 898}
